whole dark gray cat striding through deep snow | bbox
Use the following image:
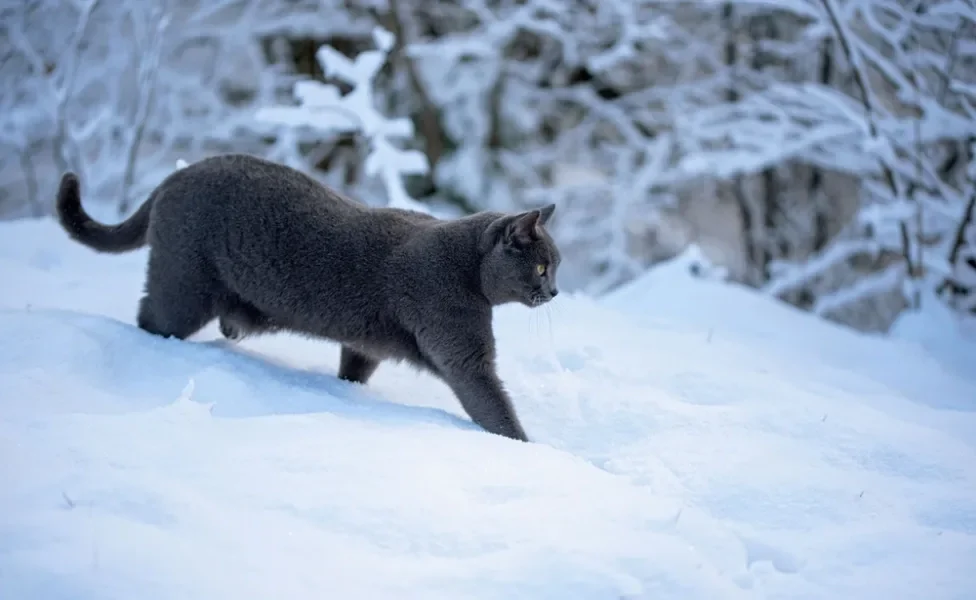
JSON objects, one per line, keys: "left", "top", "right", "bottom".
{"left": 57, "top": 154, "right": 560, "bottom": 441}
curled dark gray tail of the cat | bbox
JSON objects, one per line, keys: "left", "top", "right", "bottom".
{"left": 57, "top": 171, "right": 152, "bottom": 254}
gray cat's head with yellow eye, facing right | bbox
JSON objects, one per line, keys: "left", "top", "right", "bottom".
{"left": 481, "top": 204, "right": 562, "bottom": 307}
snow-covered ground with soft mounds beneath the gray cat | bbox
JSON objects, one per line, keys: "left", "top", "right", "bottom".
{"left": 0, "top": 221, "right": 976, "bottom": 600}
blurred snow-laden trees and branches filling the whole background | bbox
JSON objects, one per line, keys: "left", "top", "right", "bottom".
{"left": 7, "top": 0, "right": 976, "bottom": 330}
